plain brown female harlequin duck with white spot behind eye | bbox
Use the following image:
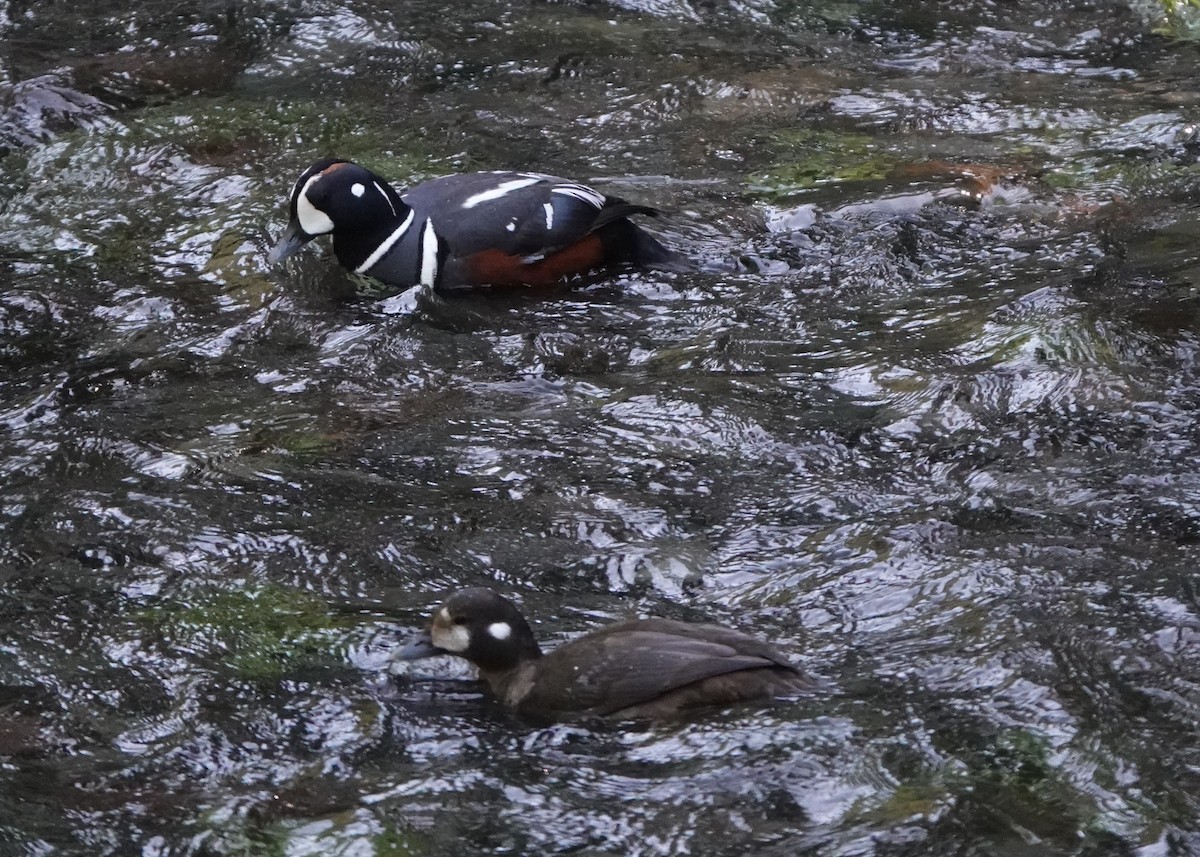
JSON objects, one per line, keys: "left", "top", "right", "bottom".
{"left": 400, "top": 588, "right": 812, "bottom": 720}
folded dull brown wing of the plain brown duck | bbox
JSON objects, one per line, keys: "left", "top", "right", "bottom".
{"left": 522, "top": 619, "right": 799, "bottom": 715}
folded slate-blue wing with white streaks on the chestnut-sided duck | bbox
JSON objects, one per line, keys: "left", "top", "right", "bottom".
{"left": 403, "top": 173, "right": 658, "bottom": 263}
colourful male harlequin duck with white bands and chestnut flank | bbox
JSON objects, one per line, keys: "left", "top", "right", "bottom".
{"left": 266, "top": 158, "right": 690, "bottom": 290}
